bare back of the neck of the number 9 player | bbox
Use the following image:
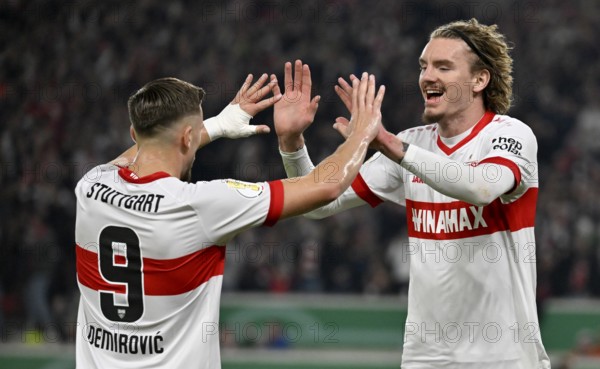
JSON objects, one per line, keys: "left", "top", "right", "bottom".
{"left": 129, "top": 143, "right": 183, "bottom": 178}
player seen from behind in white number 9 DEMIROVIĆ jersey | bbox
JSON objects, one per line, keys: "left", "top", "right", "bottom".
{"left": 75, "top": 67, "right": 384, "bottom": 369}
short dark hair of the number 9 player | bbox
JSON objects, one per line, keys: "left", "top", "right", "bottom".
{"left": 127, "top": 77, "right": 204, "bottom": 137}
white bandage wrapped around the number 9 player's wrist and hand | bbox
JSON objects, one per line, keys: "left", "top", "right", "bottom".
{"left": 204, "top": 104, "right": 256, "bottom": 141}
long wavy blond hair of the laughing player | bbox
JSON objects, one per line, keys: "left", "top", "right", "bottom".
{"left": 429, "top": 18, "right": 513, "bottom": 114}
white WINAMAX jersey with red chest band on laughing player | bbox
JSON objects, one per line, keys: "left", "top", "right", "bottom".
{"left": 352, "top": 112, "right": 550, "bottom": 369}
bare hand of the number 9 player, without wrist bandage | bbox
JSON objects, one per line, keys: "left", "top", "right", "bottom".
{"left": 346, "top": 72, "right": 385, "bottom": 142}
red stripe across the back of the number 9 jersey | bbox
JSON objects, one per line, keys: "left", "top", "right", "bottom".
{"left": 76, "top": 245, "right": 225, "bottom": 296}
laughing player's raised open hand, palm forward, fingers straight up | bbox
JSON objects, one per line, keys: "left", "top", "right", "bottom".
{"left": 273, "top": 60, "right": 321, "bottom": 151}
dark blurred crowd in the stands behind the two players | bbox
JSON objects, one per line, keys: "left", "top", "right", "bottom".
{"left": 0, "top": 0, "right": 600, "bottom": 344}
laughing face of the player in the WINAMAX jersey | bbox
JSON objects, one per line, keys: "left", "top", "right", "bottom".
{"left": 419, "top": 38, "right": 487, "bottom": 125}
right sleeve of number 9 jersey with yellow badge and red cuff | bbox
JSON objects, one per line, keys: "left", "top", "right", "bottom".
{"left": 188, "top": 179, "right": 283, "bottom": 245}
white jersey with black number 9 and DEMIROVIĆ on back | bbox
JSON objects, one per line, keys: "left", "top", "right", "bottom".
{"left": 75, "top": 164, "right": 283, "bottom": 369}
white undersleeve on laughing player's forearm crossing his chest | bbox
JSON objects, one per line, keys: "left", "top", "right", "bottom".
{"left": 400, "top": 145, "right": 515, "bottom": 206}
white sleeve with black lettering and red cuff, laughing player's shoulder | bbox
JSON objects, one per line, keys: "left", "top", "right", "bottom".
{"left": 479, "top": 119, "right": 538, "bottom": 202}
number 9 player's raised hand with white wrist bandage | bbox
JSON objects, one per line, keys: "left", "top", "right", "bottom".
{"left": 204, "top": 73, "right": 282, "bottom": 141}
